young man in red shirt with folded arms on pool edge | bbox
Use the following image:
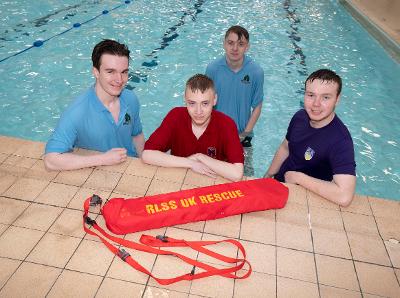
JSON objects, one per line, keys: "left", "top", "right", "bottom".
{"left": 142, "top": 74, "right": 244, "bottom": 181}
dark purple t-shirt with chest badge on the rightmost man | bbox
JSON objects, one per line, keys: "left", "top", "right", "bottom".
{"left": 275, "top": 110, "right": 356, "bottom": 182}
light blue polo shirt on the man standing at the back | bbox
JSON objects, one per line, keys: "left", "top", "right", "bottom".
{"left": 206, "top": 56, "right": 264, "bottom": 133}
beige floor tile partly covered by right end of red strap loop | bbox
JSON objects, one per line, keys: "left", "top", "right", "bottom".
{"left": 240, "top": 241, "right": 276, "bottom": 275}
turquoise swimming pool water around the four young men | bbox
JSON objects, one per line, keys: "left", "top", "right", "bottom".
{"left": 0, "top": 0, "right": 400, "bottom": 198}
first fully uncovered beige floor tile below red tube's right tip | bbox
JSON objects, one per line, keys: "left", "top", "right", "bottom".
{"left": 276, "top": 222, "right": 313, "bottom": 251}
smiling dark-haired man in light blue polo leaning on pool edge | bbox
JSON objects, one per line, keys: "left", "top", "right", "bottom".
{"left": 44, "top": 40, "right": 144, "bottom": 171}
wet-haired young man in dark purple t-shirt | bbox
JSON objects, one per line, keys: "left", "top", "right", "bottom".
{"left": 265, "top": 69, "right": 356, "bottom": 206}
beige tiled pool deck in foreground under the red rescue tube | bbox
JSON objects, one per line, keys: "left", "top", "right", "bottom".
{"left": 0, "top": 136, "right": 400, "bottom": 298}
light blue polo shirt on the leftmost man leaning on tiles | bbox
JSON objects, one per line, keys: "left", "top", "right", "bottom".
{"left": 45, "top": 86, "right": 142, "bottom": 157}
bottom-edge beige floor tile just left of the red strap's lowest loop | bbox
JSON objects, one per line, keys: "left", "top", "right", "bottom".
{"left": 96, "top": 278, "right": 145, "bottom": 298}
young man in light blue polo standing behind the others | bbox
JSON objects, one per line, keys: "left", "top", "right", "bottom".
{"left": 206, "top": 26, "right": 264, "bottom": 147}
